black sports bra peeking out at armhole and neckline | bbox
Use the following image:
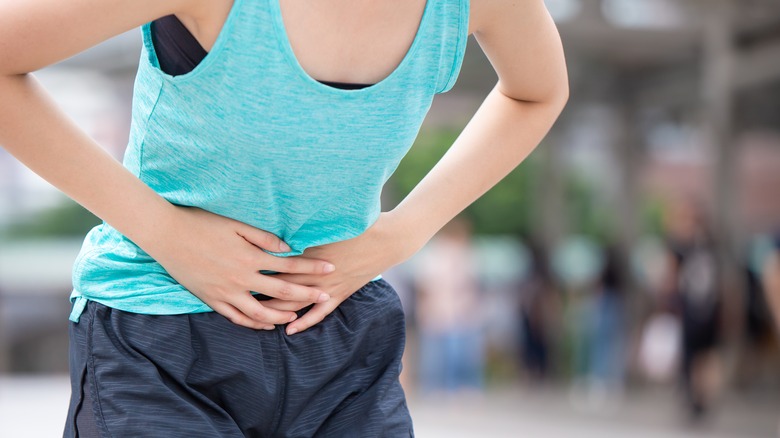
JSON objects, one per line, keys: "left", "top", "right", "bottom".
{"left": 150, "top": 14, "right": 373, "bottom": 90}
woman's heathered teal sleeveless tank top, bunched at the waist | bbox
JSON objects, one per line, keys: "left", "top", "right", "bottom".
{"left": 70, "top": 0, "right": 469, "bottom": 322}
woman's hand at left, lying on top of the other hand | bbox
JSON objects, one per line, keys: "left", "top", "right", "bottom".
{"left": 147, "top": 206, "right": 335, "bottom": 330}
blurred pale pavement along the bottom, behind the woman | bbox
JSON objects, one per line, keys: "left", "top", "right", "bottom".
{"left": 0, "top": 376, "right": 780, "bottom": 438}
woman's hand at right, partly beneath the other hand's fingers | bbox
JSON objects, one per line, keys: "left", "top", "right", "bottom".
{"left": 263, "top": 212, "right": 419, "bottom": 335}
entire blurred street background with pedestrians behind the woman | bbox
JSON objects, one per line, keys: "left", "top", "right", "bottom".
{"left": 0, "top": 0, "right": 780, "bottom": 437}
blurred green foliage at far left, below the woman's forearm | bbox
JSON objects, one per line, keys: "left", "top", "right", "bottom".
{"left": 2, "top": 199, "right": 102, "bottom": 240}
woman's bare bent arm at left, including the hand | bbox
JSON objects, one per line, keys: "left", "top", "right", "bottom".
{"left": 0, "top": 0, "right": 327, "bottom": 328}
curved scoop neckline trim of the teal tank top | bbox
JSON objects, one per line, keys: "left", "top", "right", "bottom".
{"left": 270, "top": 0, "right": 434, "bottom": 97}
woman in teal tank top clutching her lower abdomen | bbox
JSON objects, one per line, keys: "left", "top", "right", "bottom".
{"left": 0, "top": 0, "right": 568, "bottom": 437}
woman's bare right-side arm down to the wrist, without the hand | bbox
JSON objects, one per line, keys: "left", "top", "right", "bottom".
{"left": 391, "top": 0, "right": 569, "bottom": 248}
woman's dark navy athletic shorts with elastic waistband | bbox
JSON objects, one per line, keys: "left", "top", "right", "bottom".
{"left": 64, "top": 280, "right": 414, "bottom": 438}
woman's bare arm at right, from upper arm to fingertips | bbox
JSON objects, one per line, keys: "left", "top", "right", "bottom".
{"left": 271, "top": 0, "right": 569, "bottom": 333}
